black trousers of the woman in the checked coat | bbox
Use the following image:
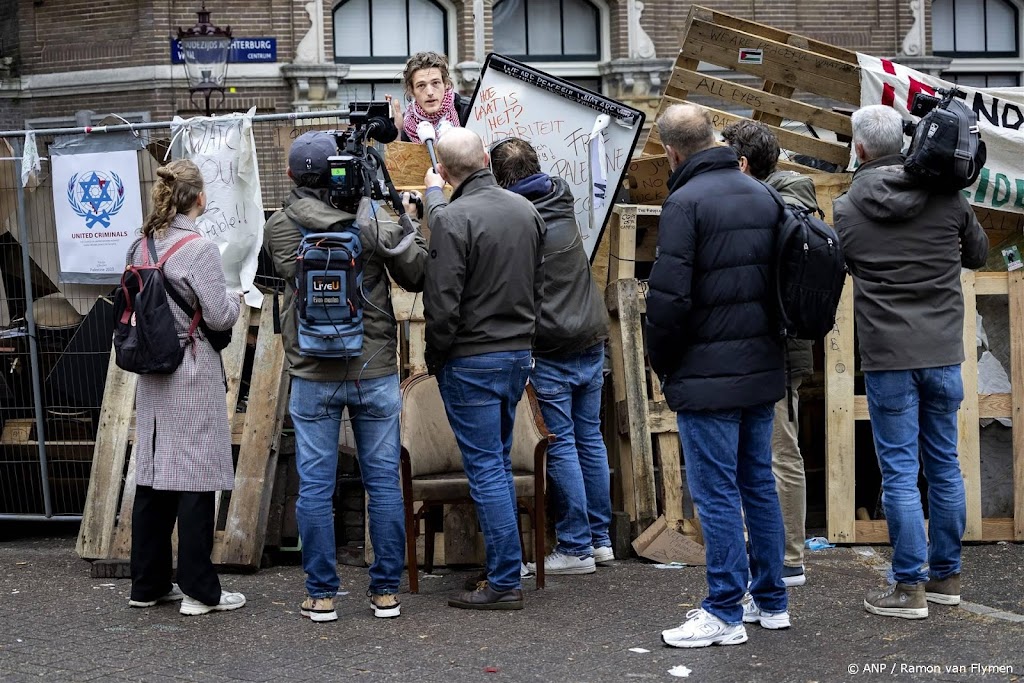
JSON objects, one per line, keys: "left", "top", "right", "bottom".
{"left": 131, "top": 486, "right": 220, "bottom": 605}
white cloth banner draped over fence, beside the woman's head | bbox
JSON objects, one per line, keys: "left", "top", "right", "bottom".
{"left": 172, "top": 110, "right": 263, "bottom": 308}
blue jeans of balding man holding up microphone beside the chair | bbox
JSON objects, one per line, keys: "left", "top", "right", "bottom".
{"left": 437, "top": 350, "right": 532, "bottom": 591}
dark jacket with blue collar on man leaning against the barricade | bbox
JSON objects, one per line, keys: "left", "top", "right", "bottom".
{"left": 509, "top": 173, "right": 608, "bottom": 357}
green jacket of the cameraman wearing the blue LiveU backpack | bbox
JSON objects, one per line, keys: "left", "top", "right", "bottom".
{"left": 263, "top": 187, "right": 427, "bottom": 382}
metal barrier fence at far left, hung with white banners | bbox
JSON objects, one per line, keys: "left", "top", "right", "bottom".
{"left": 0, "top": 111, "right": 348, "bottom": 520}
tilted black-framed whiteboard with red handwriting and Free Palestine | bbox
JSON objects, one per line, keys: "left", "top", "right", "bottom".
{"left": 466, "top": 54, "right": 644, "bottom": 260}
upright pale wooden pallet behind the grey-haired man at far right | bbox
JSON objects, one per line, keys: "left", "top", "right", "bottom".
{"left": 824, "top": 270, "right": 1024, "bottom": 543}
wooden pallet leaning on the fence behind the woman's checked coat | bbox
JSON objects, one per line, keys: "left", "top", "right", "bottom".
{"left": 76, "top": 295, "right": 288, "bottom": 568}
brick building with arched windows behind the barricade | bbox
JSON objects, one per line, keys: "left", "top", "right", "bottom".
{"left": 0, "top": 0, "right": 1024, "bottom": 129}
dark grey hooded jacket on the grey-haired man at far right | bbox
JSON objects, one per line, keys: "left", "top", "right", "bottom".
{"left": 834, "top": 156, "right": 988, "bottom": 372}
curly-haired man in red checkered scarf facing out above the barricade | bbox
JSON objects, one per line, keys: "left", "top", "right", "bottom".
{"left": 391, "top": 52, "right": 470, "bottom": 143}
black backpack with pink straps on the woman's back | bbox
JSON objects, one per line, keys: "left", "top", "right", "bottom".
{"left": 114, "top": 234, "right": 202, "bottom": 375}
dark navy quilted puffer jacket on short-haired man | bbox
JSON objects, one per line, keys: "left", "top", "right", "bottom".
{"left": 647, "top": 146, "right": 785, "bottom": 411}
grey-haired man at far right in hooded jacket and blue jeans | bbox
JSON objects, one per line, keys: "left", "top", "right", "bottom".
{"left": 835, "top": 104, "right": 988, "bottom": 618}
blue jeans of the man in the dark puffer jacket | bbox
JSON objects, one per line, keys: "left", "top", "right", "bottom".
{"left": 678, "top": 403, "right": 787, "bottom": 624}
